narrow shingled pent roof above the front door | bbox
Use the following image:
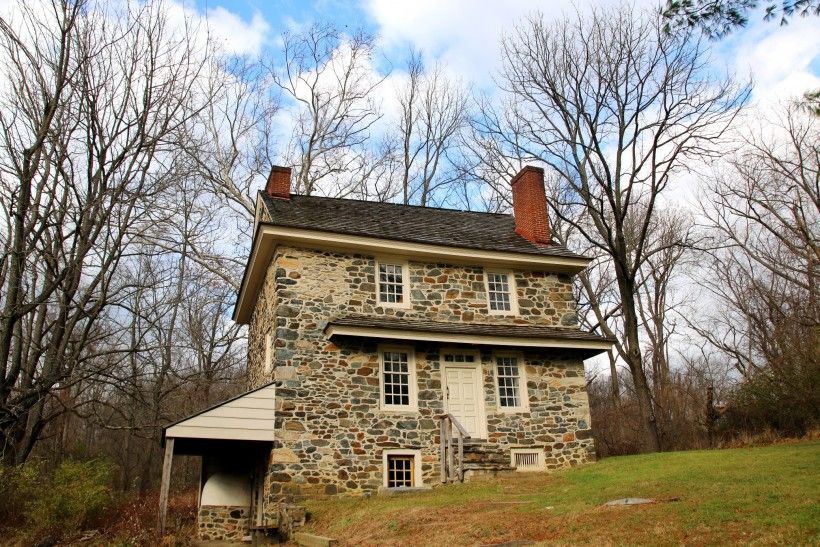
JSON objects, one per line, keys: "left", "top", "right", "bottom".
{"left": 325, "top": 315, "right": 615, "bottom": 342}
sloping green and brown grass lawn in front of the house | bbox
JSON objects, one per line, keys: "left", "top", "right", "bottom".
{"left": 305, "top": 442, "right": 820, "bottom": 545}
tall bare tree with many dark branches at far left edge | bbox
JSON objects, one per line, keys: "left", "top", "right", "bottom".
{"left": 0, "top": 0, "right": 213, "bottom": 462}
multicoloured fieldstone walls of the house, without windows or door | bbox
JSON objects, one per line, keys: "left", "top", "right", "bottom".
{"left": 249, "top": 247, "right": 593, "bottom": 503}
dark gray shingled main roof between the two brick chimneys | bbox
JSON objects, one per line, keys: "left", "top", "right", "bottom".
{"left": 260, "top": 192, "right": 584, "bottom": 258}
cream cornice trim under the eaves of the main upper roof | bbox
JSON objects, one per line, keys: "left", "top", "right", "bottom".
{"left": 233, "top": 223, "right": 590, "bottom": 325}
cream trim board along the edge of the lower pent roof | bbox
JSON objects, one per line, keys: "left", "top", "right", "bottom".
{"left": 325, "top": 324, "right": 612, "bottom": 351}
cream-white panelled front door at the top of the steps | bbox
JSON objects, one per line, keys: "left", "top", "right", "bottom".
{"left": 444, "top": 362, "right": 484, "bottom": 438}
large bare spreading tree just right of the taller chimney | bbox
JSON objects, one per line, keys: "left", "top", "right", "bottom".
{"left": 470, "top": 8, "right": 748, "bottom": 450}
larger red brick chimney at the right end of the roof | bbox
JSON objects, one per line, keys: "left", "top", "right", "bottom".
{"left": 510, "top": 165, "right": 550, "bottom": 244}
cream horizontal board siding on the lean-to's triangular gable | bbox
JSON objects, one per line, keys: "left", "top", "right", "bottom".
{"left": 165, "top": 385, "right": 276, "bottom": 441}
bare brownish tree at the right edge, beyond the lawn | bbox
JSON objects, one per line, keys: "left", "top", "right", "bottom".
{"left": 693, "top": 105, "right": 820, "bottom": 392}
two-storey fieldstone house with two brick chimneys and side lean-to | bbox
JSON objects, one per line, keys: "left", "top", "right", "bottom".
{"left": 163, "top": 167, "right": 612, "bottom": 539}
